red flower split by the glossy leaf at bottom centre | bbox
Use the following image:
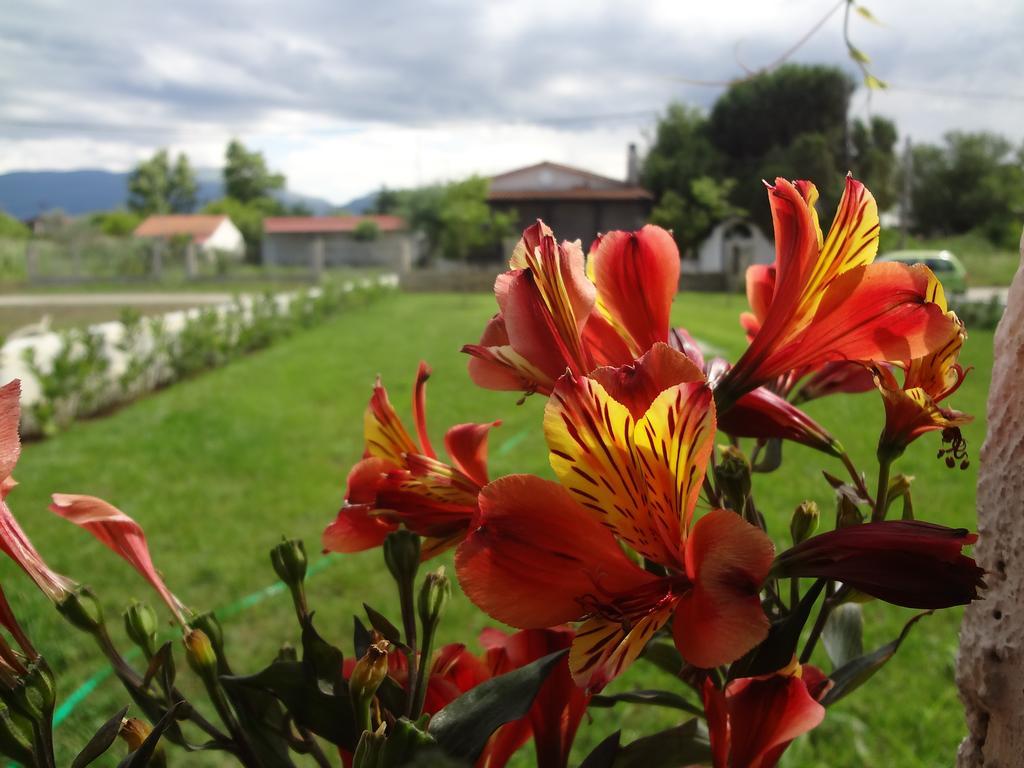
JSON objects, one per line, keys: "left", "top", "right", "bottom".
{"left": 480, "top": 628, "right": 590, "bottom": 768}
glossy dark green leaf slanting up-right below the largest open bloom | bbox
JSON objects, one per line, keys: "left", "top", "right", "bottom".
{"left": 427, "top": 648, "right": 568, "bottom": 763}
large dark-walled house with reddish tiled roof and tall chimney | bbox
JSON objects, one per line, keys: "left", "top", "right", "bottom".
{"left": 487, "top": 144, "right": 653, "bottom": 249}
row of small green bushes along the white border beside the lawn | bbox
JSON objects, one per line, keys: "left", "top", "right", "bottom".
{"left": 9, "top": 278, "right": 396, "bottom": 435}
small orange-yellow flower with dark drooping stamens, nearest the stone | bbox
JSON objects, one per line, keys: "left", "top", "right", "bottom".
{"left": 874, "top": 312, "right": 972, "bottom": 466}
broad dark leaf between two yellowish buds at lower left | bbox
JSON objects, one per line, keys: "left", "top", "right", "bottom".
{"left": 220, "top": 662, "right": 358, "bottom": 751}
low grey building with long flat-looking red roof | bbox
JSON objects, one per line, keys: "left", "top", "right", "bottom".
{"left": 263, "top": 215, "right": 417, "bottom": 271}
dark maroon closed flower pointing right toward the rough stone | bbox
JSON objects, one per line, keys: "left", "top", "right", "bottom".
{"left": 772, "top": 520, "right": 985, "bottom": 608}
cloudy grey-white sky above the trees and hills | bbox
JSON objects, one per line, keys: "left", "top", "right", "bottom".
{"left": 0, "top": 0, "right": 1024, "bottom": 203}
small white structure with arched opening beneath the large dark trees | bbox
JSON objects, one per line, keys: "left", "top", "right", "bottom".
{"left": 681, "top": 218, "right": 775, "bottom": 290}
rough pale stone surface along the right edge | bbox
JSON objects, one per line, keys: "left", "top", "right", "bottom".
{"left": 956, "top": 230, "right": 1024, "bottom": 768}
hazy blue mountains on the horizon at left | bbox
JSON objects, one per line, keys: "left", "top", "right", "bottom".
{"left": 0, "top": 169, "right": 337, "bottom": 219}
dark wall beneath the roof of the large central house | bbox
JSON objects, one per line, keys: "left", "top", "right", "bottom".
{"left": 490, "top": 200, "right": 650, "bottom": 247}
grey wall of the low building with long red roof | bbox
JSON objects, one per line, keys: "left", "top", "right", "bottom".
{"left": 263, "top": 232, "right": 416, "bottom": 271}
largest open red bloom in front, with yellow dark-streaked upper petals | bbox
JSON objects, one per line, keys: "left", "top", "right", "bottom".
{"left": 456, "top": 345, "right": 773, "bottom": 689}
